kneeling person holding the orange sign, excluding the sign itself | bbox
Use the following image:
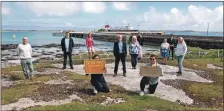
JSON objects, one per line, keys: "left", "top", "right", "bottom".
{"left": 87, "top": 54, "right": 110, "bottom": 94}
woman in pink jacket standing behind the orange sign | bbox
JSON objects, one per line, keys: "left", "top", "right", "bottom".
{"left": 86, "top": 33, "right": 95, "bottom": 59}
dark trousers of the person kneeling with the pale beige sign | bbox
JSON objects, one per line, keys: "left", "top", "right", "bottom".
{"left": 140, "top": 77, "right": 158, "bottom": 94}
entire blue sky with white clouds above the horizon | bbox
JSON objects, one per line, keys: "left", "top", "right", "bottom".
{"left": 2, "top": 2, "right": 223, "bottom": 31}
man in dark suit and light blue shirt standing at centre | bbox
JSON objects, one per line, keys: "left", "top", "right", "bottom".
{"left": 113, "top": 35, "right": 127, "bottom": 77}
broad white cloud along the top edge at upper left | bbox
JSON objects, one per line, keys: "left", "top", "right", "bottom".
{"left": 17, "top": 2, "right": 80, "bottom": 16}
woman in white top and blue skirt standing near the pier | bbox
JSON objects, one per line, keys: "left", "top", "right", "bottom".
{"left": 160, "top": 39, "right": 170, "bottom": 65}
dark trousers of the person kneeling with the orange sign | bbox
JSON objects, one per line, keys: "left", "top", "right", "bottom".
{"left": 90, "top": 74, "right": 109, "bottom": 92}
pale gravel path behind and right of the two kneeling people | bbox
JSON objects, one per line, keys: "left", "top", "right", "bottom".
{"left": 55, "top": 62, "right": 213, "bottom": 104}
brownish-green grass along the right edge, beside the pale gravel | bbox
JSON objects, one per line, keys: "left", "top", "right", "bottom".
{"left": 167, "top": 58, "right": 223, "bottom": 108}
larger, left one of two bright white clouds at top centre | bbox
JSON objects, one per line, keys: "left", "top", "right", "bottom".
{"left": 83, "top": 2, "right": 106, "bottom": 14}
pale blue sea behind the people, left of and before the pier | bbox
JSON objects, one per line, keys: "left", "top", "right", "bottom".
{"left": 1, "top": 31, "right": 159, "bottom": 52}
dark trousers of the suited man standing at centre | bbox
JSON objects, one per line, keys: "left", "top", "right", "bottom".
{"left": 114, "top": 54, "right": 126, "bottom": 74}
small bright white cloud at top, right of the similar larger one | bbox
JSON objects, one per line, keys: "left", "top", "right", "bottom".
{"left": 113, "top": 2, "right": 130, "bottom": 11}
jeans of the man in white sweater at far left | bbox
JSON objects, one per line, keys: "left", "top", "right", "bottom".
{"left": 21, "top": 59, "right": 33, "bottom": 77}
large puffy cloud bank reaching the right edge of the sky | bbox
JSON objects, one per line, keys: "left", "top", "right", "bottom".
{"left": 137, "top": 5, "right": 223, "bottom": 31}
